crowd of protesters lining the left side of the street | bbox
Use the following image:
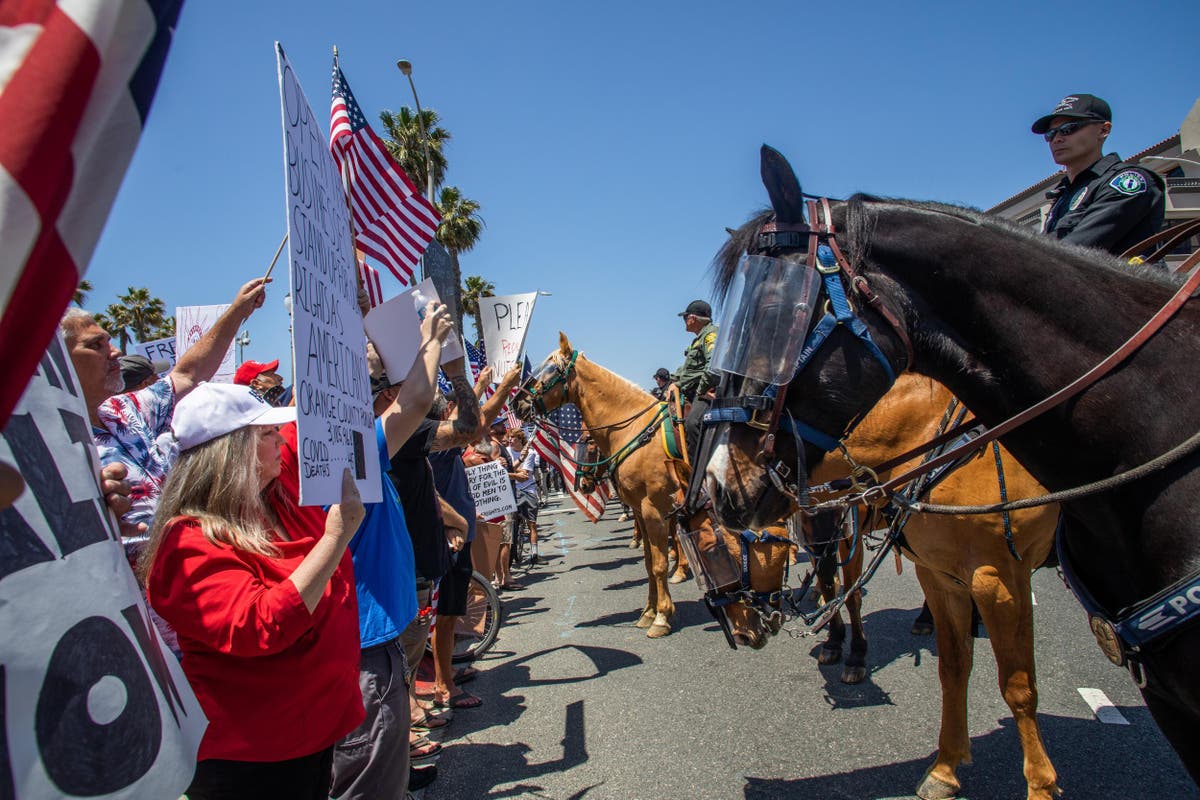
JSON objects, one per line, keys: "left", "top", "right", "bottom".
{"left": 61, "top": 279, "right": 564, "bottom": 800}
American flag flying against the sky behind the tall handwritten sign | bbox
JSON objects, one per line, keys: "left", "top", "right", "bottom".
{"left": 329, "top": 59, "right": 442, "bottom": 285}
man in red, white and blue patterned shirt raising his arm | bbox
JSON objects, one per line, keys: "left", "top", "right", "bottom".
{"left": 62, "top": 278, "right": 269, "bottom": 543}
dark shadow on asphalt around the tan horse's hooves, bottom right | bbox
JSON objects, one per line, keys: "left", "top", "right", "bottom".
{"left": 744, "top": 706, "right": 1198, "bottom": 800}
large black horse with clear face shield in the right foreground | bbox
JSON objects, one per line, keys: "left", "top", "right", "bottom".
{"left": 689, "top": 146, "right": 1200, "bottom": 796}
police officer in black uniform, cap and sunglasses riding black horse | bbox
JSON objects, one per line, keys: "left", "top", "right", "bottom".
{"left": 1032, "top": 94, "right": 1166, "bottom": 254}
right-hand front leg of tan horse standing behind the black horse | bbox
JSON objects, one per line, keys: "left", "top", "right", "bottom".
{"left": 971, "top": 561, "right": 1060, "bottom": 800}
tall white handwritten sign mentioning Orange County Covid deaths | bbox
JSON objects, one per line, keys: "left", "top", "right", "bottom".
{"left": 275, "top": 42, "right": 383, "bottom": 505}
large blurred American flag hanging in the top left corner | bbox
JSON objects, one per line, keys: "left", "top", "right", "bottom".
{"left": 0, "top": 0, "right": 182, "bottom": 428}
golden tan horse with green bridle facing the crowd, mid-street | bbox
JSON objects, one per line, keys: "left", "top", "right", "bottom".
{"left": 514, "top": 332, "right": 690, "bottom": 639}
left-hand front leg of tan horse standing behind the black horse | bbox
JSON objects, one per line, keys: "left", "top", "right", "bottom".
{"left": 917, "top": 564, "right": 974, "bottom": 800}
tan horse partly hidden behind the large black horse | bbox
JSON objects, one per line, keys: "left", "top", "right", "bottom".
{"left": 715, "top": 374, "right": 1058, "bottom": 800}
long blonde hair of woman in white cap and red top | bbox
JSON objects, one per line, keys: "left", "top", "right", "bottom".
{"left": 138, "top": 426, "right": 278, "bottom": 581}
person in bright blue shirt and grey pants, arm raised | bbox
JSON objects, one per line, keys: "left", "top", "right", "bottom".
{"left": 330, "top": 303, "right": 452, "bottom": 800}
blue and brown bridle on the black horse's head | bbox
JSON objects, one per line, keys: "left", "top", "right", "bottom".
{"left": 703, "top": 197, "right": 913, "bottom": 500}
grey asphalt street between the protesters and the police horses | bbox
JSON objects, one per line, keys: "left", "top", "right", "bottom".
{"left": 424, "top": 500, "right": 1200, "bottom": 800}
